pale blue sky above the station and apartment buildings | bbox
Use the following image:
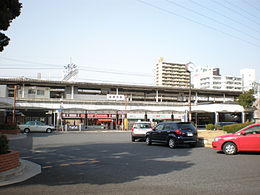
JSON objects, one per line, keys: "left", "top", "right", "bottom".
{"left": 0, "top": 0, "right": 260, "bottom": 85}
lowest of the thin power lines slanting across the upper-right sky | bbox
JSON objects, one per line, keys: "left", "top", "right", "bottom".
{"left": 136, "top": 0, "right": 260, "bottom": 48}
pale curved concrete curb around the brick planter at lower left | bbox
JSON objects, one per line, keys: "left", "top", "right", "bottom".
{"left": 0, "top": 159, "right": 41, "bottom": 186}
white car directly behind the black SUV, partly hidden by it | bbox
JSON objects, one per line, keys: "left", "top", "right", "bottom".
{"left": 131, "top": 121, "right": 152, "bottom": 142}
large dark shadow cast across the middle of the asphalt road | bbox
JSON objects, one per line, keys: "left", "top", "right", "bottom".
{"left": 6, "top": 133, "right": 194, "bottom": 186}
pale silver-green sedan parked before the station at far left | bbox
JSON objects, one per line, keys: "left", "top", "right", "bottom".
{"left": 18, "top": 121, "right": 55, "bottom": 133}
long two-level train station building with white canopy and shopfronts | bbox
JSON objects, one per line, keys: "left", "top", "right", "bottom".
{"left": 0, "top": 78, "right": 252, "bottom": 130}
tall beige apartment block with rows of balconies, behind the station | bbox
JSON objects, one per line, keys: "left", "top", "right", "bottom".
{"left": 154, "top": 58, "right": 190, "bottom": 88}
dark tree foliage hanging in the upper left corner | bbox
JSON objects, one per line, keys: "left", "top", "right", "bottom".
{"left": 0, "top": 0, "right": 22, "bottom": 52}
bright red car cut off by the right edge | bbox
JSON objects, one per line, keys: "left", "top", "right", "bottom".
{"left": 212, "top": 124, "right": 260, "bottom": 155}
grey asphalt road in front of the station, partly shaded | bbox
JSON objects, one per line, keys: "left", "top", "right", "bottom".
{"left": 0, "top": 132, "right": 260, "bottom": 195}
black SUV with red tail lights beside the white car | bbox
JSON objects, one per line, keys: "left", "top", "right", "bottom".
{"left": 146, "top": 122, "right": 198, "bottom": 148}
